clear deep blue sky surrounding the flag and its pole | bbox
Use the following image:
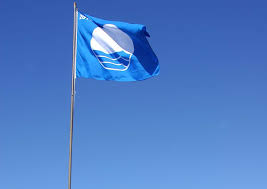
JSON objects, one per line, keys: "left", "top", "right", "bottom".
{"left": 0, "top": 0, "right": 267, "bottom": 189}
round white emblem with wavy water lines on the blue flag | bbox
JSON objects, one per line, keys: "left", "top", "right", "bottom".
{"left": 90, "top": 24, "right": 134, "bottom": 71}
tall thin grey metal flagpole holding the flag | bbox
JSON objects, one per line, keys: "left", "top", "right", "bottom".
{"left": 68, "top": 2, "right": 78, "bottom": 189}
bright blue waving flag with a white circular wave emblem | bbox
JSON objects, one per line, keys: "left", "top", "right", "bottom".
{"left": 76, "top": 13, "right": 159, "bottom": 81}
